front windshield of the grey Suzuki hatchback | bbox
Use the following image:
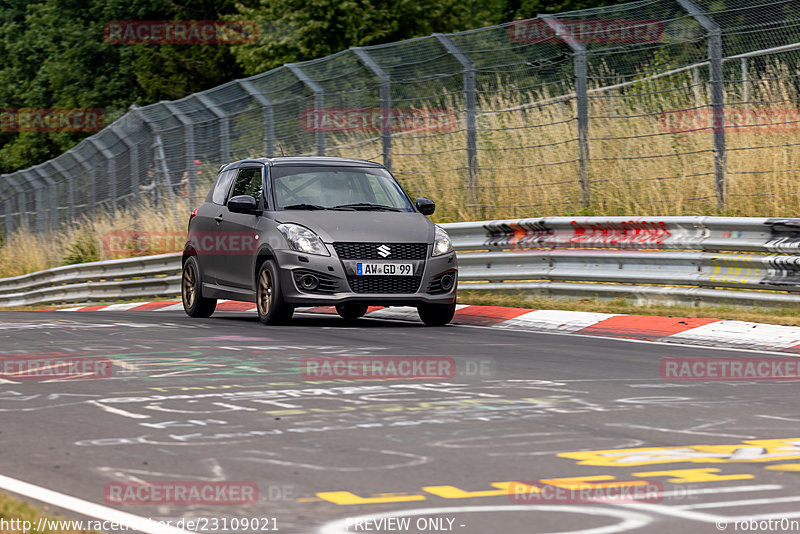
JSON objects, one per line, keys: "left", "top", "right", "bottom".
{"left": 271, "top": 166, "right": 414, "bottom": 211}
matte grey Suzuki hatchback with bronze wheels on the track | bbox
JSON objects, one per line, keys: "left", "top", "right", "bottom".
{"left": 181, "top": 157, "right": 458, "bottom": 325}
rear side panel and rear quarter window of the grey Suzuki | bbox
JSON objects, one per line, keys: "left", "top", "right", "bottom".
{"left": 189, "top": 169, "right": 237, "bottom": 285}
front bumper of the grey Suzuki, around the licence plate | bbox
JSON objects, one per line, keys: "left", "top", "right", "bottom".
{"left": 275, "top": 246, "right": 458, "bottom": 306}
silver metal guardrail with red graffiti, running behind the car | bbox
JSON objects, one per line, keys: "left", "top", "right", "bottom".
{"left": 0, "top": 217, "right": 800, "bottom": 307}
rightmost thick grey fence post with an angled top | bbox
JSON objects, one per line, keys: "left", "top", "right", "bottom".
{"left": 678, "top": 0, "right": 727, "bottom": 210}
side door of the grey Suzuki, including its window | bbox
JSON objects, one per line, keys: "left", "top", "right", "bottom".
{"left": 219, "top": 165, "right": 264, "bottom": 291}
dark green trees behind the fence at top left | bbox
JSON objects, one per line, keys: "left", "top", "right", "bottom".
{"left": 0, "top": 0, "right": 664, "bottom": 173}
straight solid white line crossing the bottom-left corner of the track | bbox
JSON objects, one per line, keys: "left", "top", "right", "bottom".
{"left": 0, "top": 475, "right": 193, "bottom": 534}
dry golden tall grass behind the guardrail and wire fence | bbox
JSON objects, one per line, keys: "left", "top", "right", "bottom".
{"left": 0, "top": 64, "right": 800, "bottom": 276}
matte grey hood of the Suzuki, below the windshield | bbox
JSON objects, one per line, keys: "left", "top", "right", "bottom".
{"left": 275, "top": 210, "right": 434, "bottom": 243}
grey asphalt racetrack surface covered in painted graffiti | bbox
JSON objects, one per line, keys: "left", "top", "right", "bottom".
{"left": 0, "top": 311, "right": 800, "bottom": 534}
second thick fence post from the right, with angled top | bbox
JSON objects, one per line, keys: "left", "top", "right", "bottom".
{"left": 539, "top": 15, "right": 591, "bottom": 209}
